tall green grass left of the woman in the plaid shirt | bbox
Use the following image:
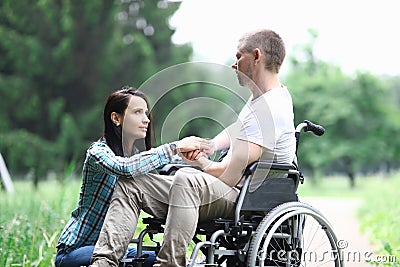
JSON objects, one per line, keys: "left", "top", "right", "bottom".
{"left": 0, "top": 181, "right": 80, "bottom": 267}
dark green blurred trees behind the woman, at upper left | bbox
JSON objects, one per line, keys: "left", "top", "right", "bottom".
{"left": 0, "top": 0, "right": 191, "bottom": 184}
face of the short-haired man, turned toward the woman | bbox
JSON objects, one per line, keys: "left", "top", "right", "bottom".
{"left": 232, "top": 47, "right": 254, "bottom": 86}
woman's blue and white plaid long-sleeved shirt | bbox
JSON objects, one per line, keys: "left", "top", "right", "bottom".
{"left": 57, "top": 141, "right": 172, "bottom": 253}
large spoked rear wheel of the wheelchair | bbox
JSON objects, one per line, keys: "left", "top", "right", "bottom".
{"left": 247, "top": 202, "right": 344, "bottom": 267}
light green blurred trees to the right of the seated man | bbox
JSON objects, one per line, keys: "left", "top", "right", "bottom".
{"left": 286, "top": 29, "right": 400, "bottom": 186}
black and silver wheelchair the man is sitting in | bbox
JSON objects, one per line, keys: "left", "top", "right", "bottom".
{"left": 122, "top": 120, "right": 344, "bottom": 267}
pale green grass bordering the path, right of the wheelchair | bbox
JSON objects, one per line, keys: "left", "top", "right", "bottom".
{"left": 298, "top": 173, "right": 400, "bottom": 266}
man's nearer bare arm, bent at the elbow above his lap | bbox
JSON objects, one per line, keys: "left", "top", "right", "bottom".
{"left": 190, "top": 139, "right": 263, "bottom": 186}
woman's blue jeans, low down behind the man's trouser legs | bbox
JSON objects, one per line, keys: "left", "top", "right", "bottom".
{"left": 56, "top": 246, "right": 156, "bottom": 267}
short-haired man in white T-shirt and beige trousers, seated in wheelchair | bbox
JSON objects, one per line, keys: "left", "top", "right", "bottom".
{"left": 92, "top": 30, "right": 296, "bottom": 267}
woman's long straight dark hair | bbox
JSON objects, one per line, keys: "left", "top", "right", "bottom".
{"left": 103, "top": 86, "right": 153, "bottom": 156}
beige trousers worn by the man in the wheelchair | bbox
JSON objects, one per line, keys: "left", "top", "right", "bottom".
{"left": 92, "top": 168, "right": 239, "bottom": 267}
